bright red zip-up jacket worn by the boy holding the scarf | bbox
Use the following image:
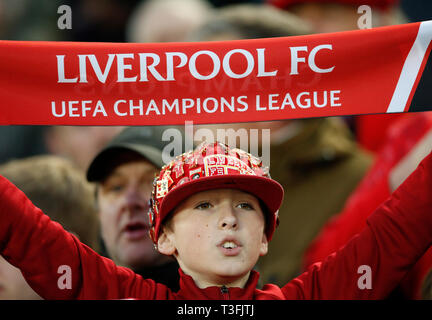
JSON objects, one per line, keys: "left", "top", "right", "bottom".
{"left": 0, "top": 154, "right": 432, "bottom": 300}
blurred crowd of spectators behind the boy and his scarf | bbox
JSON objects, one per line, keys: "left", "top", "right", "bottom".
{"left": 0, "top": 0, "right": 432, "bottom": 299}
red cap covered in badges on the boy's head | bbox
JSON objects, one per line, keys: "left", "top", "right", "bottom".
{"left": 149, "top": 142, "right": 284, "bottom": 244}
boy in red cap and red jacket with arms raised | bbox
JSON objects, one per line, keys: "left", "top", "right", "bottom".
{"left": 0, "top": 143, "right": 432, "bottom": 299}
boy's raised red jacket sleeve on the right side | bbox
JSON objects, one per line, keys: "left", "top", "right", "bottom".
{"left": 282, "top": 154, "right": 432, "bottom": 299}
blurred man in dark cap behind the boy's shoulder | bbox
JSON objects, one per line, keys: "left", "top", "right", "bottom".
{"left": 87, "top": 126, "right": 179, "bottom": 290}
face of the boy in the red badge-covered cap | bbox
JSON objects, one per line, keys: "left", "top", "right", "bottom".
{"left": 158, "top": 189, "right": 268, "bottom": 288}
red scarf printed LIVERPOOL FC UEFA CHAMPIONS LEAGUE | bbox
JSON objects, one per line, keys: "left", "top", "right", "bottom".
{"left": 0, "top": 21, "right": 432, "bottom": 125}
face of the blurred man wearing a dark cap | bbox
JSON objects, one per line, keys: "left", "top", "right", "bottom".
{"left": 98, "top": 158, "right": 168, "bottom": 270}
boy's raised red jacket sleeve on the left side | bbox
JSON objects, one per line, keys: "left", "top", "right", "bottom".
{"left": 0, "top": 176, "right": 168, "bottom": 299}
